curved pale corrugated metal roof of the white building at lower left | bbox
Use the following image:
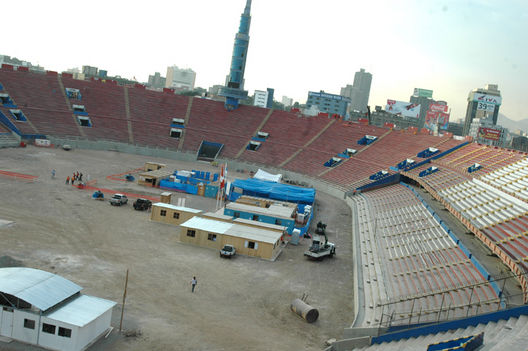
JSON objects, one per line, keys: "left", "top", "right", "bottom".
{"left": 0, "top": 267, "right": 82, "bottom": 311}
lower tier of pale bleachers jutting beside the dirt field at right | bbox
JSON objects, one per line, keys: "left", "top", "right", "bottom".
{"left": 357, "top": 185, "right": 499, "bottom": 326}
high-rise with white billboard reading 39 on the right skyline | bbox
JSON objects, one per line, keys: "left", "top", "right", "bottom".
{"left": 463, "top": 84, "right": 502, "bottom": 135}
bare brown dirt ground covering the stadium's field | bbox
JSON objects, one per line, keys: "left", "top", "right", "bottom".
{"left": 0, "top": 146, "right": 354, "bottom": 350}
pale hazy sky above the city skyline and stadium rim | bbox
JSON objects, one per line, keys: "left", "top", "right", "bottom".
{"left": 0, "top": 0, "right": 528, "bottom": 120}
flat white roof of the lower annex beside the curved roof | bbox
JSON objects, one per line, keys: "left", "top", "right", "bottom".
{"left": 45, "top": 295, "right": 116, "bottom": 327}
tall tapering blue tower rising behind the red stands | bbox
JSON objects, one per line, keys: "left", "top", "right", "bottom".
{"left": 220, "top": 0, "right": 251, "bottom": 111}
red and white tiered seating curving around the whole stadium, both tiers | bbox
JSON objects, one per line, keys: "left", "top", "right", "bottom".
{"left": 5, "top": 68, "right": 528, "bottom": 351}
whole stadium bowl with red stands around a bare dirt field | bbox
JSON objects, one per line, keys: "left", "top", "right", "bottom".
{"left": 0, "top": 0, "right": 528, "bottom": 350}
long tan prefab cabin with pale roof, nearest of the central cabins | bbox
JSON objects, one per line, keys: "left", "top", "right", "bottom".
{"left": 180, "top": 217, "right": 282, "bottom": 260}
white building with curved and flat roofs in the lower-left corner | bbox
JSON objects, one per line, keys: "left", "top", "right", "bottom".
{"left": 0, "top": 267, "right": 116, "bottom": 351}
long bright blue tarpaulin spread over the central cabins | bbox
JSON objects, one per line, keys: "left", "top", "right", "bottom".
{"left": 229, "top": 178, "right": 315, "bottom": 205}
